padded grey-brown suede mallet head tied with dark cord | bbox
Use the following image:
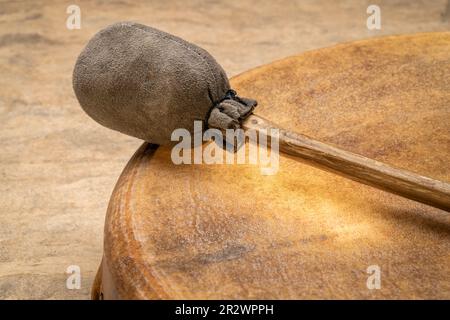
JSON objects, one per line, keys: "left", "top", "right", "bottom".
{"left": 73, "top": 22, "right": 256, "bottom": 145}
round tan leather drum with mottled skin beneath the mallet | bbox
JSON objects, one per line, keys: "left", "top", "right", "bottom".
{"left": 93, "top": 33, "right": 450, "bottom": 299}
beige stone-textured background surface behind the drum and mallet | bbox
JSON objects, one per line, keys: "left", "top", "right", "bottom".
{"left": 0, "top": 0, "right": 450, "bottom": 299}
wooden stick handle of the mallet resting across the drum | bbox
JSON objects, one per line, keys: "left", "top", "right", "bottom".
{"left": 242, "top": 114, "right": 450, "bottom": 211}
